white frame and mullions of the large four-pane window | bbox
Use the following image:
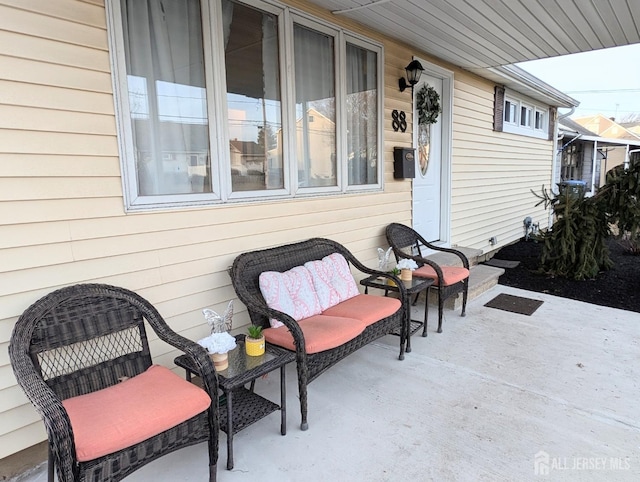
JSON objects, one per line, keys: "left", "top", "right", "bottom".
{"left": 105, "top": 0, "right": 384, "bottom": 212}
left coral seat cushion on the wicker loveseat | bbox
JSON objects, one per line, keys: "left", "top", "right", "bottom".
{"left": 262, "top": 315, "right": 366, "bottom": 353}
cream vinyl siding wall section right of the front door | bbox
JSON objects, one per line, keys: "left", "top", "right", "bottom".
{"left": 451, "top": 72, "right": 553, "bottom": 252}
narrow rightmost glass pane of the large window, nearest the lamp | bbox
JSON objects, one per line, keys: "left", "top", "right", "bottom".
{"left": 347, "top": 44, "right": 378, "bottom": 186}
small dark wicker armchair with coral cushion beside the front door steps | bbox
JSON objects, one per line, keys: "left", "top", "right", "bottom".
{"left": 386, "top": 223, "right": 469, "bottom": 336}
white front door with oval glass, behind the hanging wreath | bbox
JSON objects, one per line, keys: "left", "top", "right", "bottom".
{"left": 413, "top": 72, "right": 447, "bottom": 242}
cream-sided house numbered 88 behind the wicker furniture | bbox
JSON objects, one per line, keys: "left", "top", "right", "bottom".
{"left": 0, "top": 0, "right": 640, "bottom": 458}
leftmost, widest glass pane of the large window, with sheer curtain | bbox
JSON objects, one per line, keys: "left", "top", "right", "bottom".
{"left": 121, "top": 0, "right": 211, "bottom": 196}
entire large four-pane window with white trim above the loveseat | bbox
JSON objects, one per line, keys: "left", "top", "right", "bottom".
{"left": 107, "top": 0, "right": 382, "bottom": 210}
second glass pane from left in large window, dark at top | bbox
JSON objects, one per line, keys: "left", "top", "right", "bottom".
{"left": 222, "top": 0, "right": 284, "bottom": 192}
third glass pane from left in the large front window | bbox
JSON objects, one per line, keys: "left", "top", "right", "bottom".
{"left": 293, "top": 24, "right": 337, "bottom": 187}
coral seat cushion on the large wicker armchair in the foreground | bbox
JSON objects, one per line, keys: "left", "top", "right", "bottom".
{"left": 62, "top": 365, "right": 211, "bottom": 462}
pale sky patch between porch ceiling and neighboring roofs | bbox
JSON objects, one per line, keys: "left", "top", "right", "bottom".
{"left": 518, "top": 44, "right": 640, "bottom": 122}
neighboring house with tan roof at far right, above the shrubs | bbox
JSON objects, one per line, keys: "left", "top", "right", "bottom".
{"left": 573, "top": 114, "right": 640, "bottom": 186}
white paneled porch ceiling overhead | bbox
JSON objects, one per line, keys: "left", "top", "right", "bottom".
{"left": 309, "top": 0, "right": 640, "bottom": 68}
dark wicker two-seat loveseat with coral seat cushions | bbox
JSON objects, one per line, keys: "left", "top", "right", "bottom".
{"left": 230, "top": 238, "right": 407, "bottom": 430}
